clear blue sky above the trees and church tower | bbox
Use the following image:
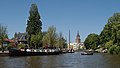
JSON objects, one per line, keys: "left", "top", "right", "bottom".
{"left": 0, "top": 0, "right": 120, "bottom": 42}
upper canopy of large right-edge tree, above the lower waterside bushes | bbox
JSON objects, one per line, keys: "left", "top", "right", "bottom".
{"left": 100, "top": 13, "right": 120, "bottom": 45}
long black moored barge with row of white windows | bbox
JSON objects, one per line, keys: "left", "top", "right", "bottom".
{"left": 9, "top": 49, "right": 60, "bottom": 56}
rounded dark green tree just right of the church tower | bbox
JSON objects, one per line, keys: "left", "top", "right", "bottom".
{"left": 84, "top": 33, "right": 99, "bottom": 50}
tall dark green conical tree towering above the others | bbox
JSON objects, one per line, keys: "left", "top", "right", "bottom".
{"left": 26, "top": 4, "right": 42, "bottom": 44}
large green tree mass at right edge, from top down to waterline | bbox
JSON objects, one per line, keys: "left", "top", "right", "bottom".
{"left": 100, "top": 13, "right": 120, "bottom": 54}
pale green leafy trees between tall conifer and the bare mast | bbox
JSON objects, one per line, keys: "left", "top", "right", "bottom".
{"left": 42, "top": 26, "right": 67, "bottom": 48}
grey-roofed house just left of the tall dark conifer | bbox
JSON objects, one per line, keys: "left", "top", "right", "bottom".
{"left": 14, "top": 32, "right": 27, "bottom": 44}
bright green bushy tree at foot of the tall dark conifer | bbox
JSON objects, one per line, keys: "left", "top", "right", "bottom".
{"left": 30, "top": 33, "right": 42, "bottom": 48}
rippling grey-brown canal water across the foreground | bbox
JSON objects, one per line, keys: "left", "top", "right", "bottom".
{"left": 0, "top": 52, "right": 120, "bottom": 68}
